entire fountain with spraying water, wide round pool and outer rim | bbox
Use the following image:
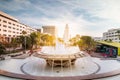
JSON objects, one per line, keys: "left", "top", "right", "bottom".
{"left": 0, "top": 25, "right": 120, "bottom": 80}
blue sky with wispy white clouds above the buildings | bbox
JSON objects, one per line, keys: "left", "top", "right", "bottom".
{"left": 0, "top": 0, "right": 120, "bottom": 37}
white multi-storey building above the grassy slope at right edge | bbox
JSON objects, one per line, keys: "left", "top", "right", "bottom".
{"left": 103, "top": 28, "right": 120, "bottom": 42}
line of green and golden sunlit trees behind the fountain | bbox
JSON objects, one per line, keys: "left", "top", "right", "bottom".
{"left": 0, "top": 31, "right": 96, "bottom": 53}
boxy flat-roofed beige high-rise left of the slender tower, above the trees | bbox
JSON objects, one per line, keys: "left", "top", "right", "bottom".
{"left": 42, "top": 26, "right": 57, "bottom": 36}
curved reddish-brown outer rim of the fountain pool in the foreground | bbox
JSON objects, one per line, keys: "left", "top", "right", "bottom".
{"left": 0, "top": 57, "right": 120, "bottom": 80}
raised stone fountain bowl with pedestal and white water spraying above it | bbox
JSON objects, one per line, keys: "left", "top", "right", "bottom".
{"left": 34, "top": 45, "right": 84, "bottom": 67}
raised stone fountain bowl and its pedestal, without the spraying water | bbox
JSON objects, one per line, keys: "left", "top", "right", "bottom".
{"left": 34, "top": 52, "right": 85, "bottom": 67}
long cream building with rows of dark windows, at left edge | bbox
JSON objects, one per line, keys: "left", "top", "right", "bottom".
{"left": 0, "top": 11, "right": 36, "bottom": 41}
